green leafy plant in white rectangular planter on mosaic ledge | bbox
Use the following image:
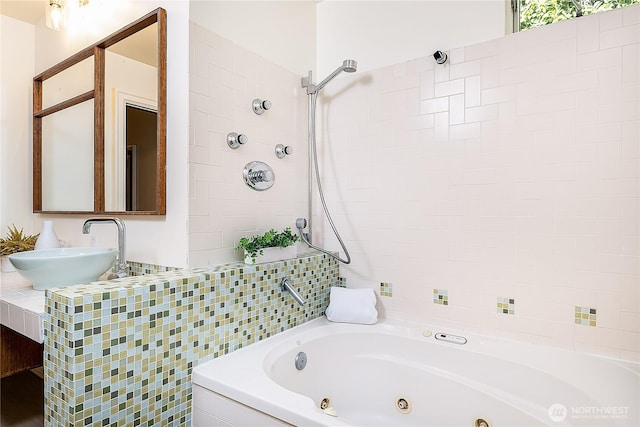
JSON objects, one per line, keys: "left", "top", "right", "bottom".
{"left": 236, "top": 227, "right": 299, "bottom": 264}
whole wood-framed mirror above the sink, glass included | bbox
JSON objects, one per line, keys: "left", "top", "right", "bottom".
{"left": 33, "top": 8, "right": 167, "bottom": 215}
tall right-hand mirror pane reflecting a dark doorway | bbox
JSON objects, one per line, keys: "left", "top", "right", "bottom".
{"left": 104, "top": 24, "right": 158, "bottom": 211}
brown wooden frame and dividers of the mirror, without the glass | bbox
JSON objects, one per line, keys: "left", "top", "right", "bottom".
{"left": 33, "top": 8, "right": 167, "bottom": 215}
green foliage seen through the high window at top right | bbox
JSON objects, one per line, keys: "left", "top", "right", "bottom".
{"left": 518, "top": 0, "right": 640, "bottom": 31}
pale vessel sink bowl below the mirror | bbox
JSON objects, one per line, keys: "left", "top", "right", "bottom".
{"left": 9, "top": 248, "right": 117, "bottom": 290}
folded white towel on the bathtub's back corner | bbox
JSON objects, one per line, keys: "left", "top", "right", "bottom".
{"left": 325, "top": 286, "right": 378, "bottom": 325}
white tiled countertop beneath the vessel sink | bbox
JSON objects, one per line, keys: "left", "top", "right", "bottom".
{"left": 0, "top": 272, "right": 44, "bottom": 343}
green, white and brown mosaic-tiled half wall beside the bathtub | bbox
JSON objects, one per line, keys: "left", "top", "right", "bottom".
{"left": 44, "top": 254, "right": 338, "bottom": 427}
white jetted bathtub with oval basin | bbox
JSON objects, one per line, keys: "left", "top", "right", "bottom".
{"left": 192, "top": 317, "right": 640, "bottom": 427}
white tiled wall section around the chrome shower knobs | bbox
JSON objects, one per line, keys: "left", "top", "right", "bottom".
{"left": 188, "top": 22, "right": 307, "bottom": 266}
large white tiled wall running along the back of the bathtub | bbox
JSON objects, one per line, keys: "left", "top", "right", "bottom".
{"left": 319, "top": 6, "right": 640, "bottom": 359}
